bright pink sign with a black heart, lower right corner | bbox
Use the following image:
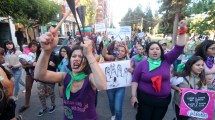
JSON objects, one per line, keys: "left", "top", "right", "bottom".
{"left": 180, "top": 88, "right": 214, "bottom": 120}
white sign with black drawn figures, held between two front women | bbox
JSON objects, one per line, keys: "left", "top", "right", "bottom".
{"left": 99, "top": 60, "right": 132, "bottom": 89}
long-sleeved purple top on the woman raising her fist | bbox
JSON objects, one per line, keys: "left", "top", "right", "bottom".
{"left": 132, "top": 45, "right": 184, "bottom": 98}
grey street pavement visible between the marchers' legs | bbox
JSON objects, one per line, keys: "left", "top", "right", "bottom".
{"left": 16, "top": 82, "right": 174, "bottom": 120}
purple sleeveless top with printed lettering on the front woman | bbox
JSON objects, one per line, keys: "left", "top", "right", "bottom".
{"left": 63, "top": 74, "right": 98, "bottom": 120}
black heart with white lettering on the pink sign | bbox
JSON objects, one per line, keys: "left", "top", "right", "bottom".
{"left": 184, "top": 92, "right": 209, "bottom": 111}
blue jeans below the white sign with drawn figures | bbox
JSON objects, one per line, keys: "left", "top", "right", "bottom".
{"left": 107, "top": 87, "right": 125, "bottom": 120}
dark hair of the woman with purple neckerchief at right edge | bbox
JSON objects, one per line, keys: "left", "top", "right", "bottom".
{"left": 194, "top": 40, "right": 215, "bottom": 61}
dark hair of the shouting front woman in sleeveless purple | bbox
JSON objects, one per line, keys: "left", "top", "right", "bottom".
{"left": 67, "top": 44, "right": 92, "bottom": 74}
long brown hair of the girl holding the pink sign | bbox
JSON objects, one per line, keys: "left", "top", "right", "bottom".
{"left": 174, "top": 56, "right": 206, "bottom": 88}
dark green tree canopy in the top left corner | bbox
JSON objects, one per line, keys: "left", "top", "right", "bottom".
{"left": 0, "top": 0, "right": 61, "bottom": 24}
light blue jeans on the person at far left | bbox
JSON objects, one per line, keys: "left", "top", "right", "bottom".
{"left": 11, "top": 68, "right": 25, "bottom": 97}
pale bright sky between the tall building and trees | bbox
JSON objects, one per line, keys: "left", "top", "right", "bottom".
{"left": 110, "top": 0, "right": 159, "bottom": 27}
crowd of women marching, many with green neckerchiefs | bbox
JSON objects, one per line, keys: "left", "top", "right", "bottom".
{"left": 0, "top": 20, "right": 215, "bottom": 120}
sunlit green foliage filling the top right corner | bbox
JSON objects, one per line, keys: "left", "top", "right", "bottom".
{"left": 185, "top": 0, "right": 215, "bottom": 34}
